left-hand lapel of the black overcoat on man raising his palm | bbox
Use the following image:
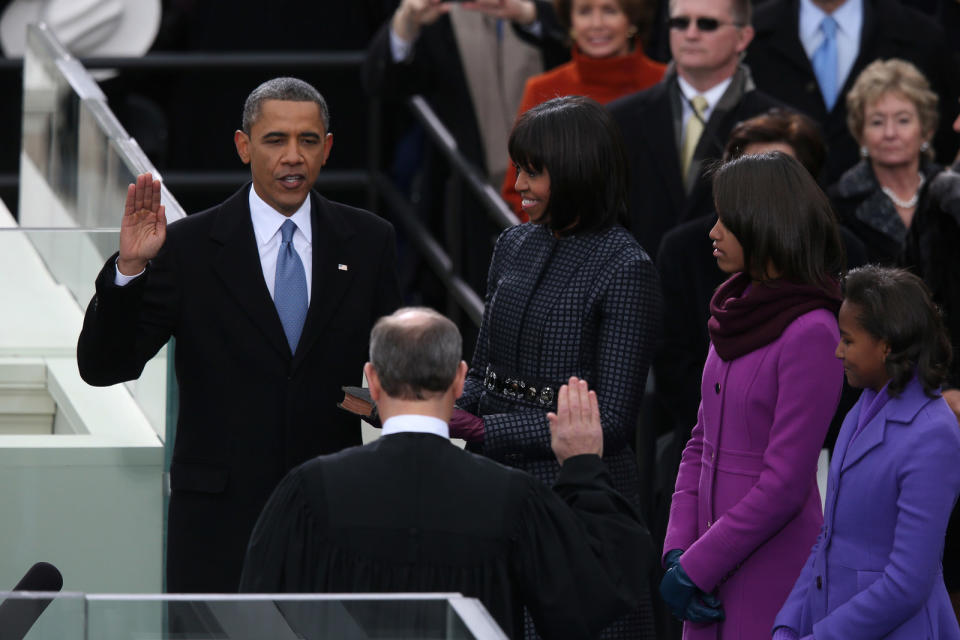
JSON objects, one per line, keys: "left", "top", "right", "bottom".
{"left": 210, "top": 184, "right": 290, "bottom": 358}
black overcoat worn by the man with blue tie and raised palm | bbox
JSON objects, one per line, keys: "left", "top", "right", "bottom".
{"left": 77, "top": 185, "right": 400, "bottom": 593}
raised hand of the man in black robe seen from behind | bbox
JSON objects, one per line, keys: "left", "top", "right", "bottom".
{"left": 547, "top": 377, "right": 603, "bottom": 464}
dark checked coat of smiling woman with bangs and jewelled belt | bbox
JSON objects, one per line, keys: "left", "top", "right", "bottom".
{"left": 457, "top": 224, "right": 661, "bottom": 504}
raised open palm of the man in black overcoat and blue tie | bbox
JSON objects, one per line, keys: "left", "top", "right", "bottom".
{"left": 117, "top": 173, "right": 167, "bottom": 276}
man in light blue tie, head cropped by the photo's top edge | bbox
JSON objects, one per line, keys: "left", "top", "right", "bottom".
{"left": 746, "top": 0, "right": 960, "bottom": 185}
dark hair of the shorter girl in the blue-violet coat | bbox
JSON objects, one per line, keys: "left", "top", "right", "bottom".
{"left": 843, "top": 264, "right": 951, "bottom": 396}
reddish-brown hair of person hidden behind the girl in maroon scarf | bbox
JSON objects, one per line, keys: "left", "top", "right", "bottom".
{"left": 723, "top": 107, "right": 827, "bottom": 178}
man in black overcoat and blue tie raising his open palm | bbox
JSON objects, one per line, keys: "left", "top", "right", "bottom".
{"left": 77, "top": 78, "right": 400, "bottom": 592}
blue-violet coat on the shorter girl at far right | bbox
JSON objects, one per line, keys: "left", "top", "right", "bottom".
{"left": 775, "top": 380, "right": 960, "bottom": 640}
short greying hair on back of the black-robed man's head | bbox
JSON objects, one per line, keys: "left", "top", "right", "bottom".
{"left": 370, "top": 307, "right": 463, "bottom": 400}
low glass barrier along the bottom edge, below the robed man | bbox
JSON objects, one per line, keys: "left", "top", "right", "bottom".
{"left": 0, "top": 593, "right": 507, "bottom": 640}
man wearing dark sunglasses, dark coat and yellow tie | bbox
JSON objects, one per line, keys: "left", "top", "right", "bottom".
{"left": 608, "top": 0, "right": 779, "bottom": 264}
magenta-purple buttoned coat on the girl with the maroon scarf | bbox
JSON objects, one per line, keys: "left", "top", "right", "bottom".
{"left": 663, "top": 309, "right": 843, "bottom": 640}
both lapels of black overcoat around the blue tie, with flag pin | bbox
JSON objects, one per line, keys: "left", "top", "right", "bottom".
{"left": 210, "top": 183, "right": 353, "bottom": 368}
